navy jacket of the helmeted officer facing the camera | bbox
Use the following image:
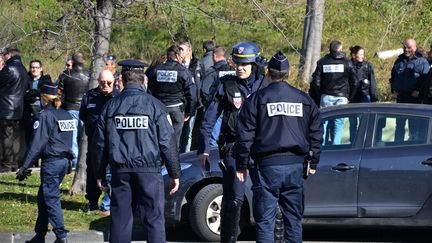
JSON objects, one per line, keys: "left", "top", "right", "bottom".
{"left": 197, "top": 71, "right": 267, "bottom": 154}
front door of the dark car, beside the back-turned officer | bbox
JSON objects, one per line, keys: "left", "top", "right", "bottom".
{"left": 304, "top": 113, "right": 368, "bottom": 218}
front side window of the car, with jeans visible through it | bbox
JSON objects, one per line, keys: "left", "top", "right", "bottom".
{"left": 322, "top": 114, "right": 362, "bottom": 150}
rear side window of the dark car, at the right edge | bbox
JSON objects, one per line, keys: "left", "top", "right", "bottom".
{"left": 373, "top": 114, "right": 429, "bottom": 147}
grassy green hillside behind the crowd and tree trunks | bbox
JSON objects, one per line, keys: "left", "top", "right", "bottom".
{"left": 0, "top": 0, "right": 432, "bottom": 100}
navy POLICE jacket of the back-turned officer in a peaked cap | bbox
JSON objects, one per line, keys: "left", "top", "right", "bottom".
{"left": 91, "top": 83, "right": 180, "bottom": 179}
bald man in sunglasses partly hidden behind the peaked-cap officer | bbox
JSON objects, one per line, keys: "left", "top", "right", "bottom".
{"left": 80, "top": 70, "right": 118, "bottom": 215}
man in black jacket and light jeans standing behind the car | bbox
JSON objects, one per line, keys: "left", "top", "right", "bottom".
{"left": 311, "top": 40, "right": 358, "bottom": 145}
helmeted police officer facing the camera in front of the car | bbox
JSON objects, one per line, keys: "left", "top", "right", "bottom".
{"left": 198, "top": 42, "right": 267, "bottom": 242}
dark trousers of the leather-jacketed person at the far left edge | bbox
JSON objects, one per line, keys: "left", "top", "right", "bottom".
{"left": 0, "top": 120, "right": 26, "bottom": 172}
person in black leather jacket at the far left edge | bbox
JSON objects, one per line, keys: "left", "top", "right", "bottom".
{"left": 0, "top": 48, "right": 30, "bottom": 171}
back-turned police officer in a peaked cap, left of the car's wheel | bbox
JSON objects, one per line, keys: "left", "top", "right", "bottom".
{"left": 92, "top": 60, "right": 180, "bottom": 243}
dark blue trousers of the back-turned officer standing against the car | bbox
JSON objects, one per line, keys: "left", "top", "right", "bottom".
{"left": 250, "top": 163, "right": 304, "bottom": 243}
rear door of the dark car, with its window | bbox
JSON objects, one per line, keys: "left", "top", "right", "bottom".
{"left": 358, "top": 113, "right": 432, "bottom": 218}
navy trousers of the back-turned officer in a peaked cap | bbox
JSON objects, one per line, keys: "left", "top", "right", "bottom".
{"left": 110, "top": 171, "right": 165, "bottom": 243}
